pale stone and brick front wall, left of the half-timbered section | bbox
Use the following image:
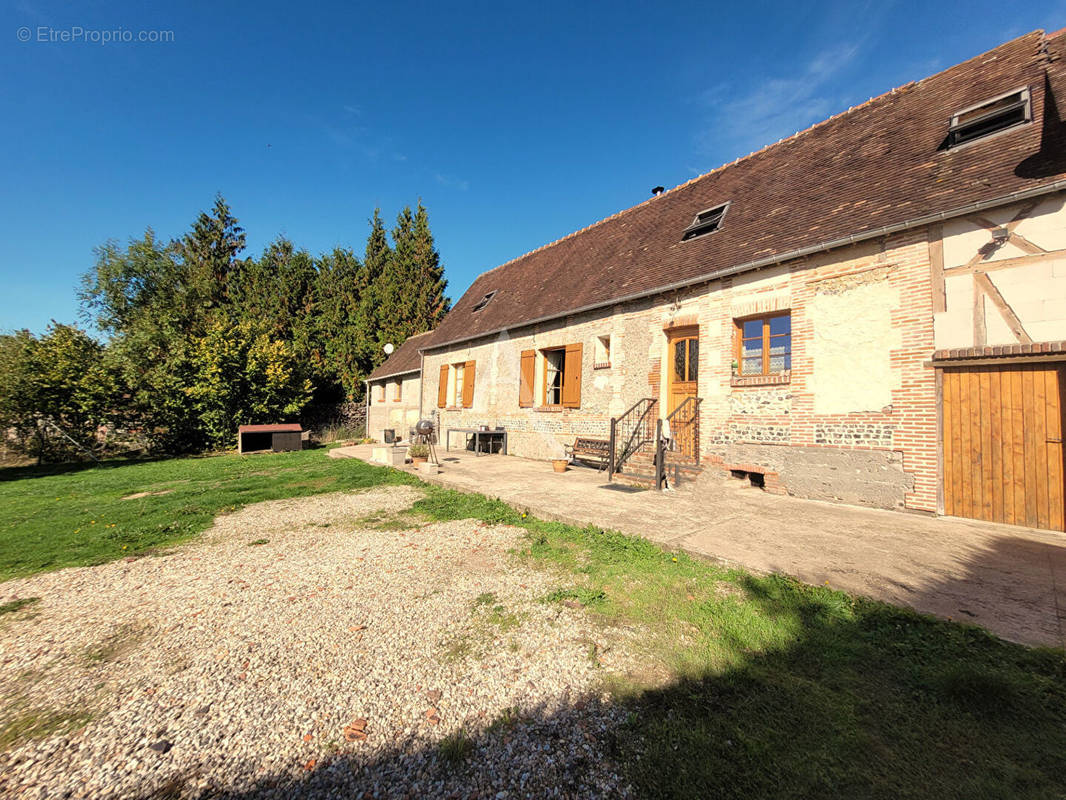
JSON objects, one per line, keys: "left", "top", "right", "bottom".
{"left": 423, "top": 222, "right": 950, "bottom": 511}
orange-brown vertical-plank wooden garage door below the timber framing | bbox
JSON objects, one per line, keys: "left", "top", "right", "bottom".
{"left": 942, "top": 363, "right": 1066, "bottom": 530}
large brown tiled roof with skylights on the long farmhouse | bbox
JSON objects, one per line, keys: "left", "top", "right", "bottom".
{"left": 424, "top": 31, "right": 1066, "bottom": 349}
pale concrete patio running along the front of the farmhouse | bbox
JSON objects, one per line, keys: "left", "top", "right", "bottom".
{"left": 329, "top": 445, "right": 1066, "bottom": 647}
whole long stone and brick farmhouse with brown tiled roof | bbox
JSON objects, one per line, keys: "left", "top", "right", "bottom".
{"left": 368, "top": 31, "right": 1066, "bottom": 530}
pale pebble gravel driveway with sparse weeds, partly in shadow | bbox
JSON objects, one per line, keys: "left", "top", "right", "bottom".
{"left": 0, "top": 486, "right": 633, "bottom": 798}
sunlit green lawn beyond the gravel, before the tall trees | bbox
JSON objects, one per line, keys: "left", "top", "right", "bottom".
{"left": 0, "top": 450, "right": 418, "bottom": 580}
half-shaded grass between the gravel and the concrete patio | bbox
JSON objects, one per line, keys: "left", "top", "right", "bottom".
{"left": 518, "top": 521, "right": 1066, "bottom": 800}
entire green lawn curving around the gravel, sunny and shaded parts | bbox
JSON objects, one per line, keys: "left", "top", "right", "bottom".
{"left": 0, "top": 450, "right": 1066, "bottom": 800}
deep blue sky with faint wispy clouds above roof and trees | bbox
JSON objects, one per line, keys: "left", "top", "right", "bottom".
{"left": 0, "top": 0, "right": 1066, "bottom": 331}
